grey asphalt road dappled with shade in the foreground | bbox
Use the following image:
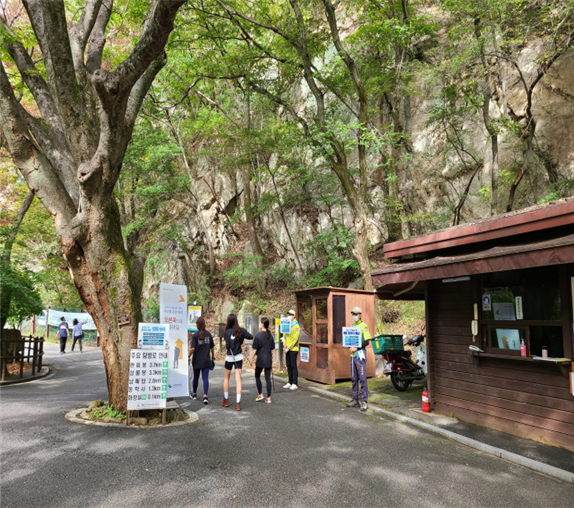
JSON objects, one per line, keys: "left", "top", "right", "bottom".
{"left": 0, "top": 345, "right": 574, "bottom": 508}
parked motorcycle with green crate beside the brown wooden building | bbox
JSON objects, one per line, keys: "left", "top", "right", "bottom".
{"left": 382, "top": 335, "right": 427, "bottom": 392}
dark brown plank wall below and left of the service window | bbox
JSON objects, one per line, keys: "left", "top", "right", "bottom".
{"left": 427, "top": 278, "right": 574, "bottom": 451}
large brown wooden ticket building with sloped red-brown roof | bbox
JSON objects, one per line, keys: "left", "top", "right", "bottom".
{"left": 372, "top": 199, "right": 574, "bottom": 451}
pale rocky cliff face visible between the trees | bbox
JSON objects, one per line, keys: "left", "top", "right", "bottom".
{"left": 141, "top": 41, "right": 574, "bottom": 310}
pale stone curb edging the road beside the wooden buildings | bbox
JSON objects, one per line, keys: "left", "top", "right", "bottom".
{"left": 307, "top": 386, "right": 574, "bottom": 485}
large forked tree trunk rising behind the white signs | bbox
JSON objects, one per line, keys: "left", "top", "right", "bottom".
{"left": 0, "top": 0, "right": 185, "bottom": 411}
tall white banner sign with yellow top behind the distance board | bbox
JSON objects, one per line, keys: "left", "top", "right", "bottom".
{"left": 159, "top": 282, "right": 189, "bottom": 397}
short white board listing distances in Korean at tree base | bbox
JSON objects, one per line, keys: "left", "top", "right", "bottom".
{"left": 128, "top": 349, "right": 169, "bottom": 411}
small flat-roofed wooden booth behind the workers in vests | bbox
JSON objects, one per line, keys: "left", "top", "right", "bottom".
{"left": 294, "top": 287, "right": 375, "bottom": 384}
